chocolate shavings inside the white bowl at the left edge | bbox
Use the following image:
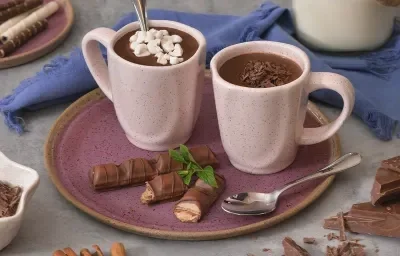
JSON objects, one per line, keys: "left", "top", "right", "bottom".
{"left": 0, "top": 182, "right": 22, "bottom": 218}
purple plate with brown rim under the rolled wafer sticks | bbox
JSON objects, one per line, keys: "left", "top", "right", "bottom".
{"left": 0, "top": 0, "right": 74, "bottom": 69}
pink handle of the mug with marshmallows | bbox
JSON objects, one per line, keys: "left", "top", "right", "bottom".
{"left": 82, "top": 28, "right": 116, "bottom": 101}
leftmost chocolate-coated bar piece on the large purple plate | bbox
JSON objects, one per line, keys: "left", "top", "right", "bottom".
{"left": 89, "top": 158, "right": 157, "bottom": 190}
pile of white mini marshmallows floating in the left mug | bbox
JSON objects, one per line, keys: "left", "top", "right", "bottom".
{"left": 129, "top": 28, "right": 183, "bottom": 65}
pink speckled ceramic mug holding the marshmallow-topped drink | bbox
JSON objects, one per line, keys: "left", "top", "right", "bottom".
{"left": 82, "top": 20, "right": 206, "bottom": 151}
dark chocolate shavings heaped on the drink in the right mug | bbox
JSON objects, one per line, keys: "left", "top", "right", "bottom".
{"left": 240, "top": 60, "right": 292, "bottom": 88}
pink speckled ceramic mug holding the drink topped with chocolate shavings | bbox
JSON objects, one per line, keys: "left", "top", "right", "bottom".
{"left": 211, "top": 41, "right": 354, "bottom": 174}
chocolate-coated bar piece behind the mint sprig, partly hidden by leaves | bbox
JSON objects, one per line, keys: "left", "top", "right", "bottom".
{"left": 155, "top": 145, "right": 218, "bottom": 174}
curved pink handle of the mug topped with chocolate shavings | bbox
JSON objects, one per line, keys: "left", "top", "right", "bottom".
{"left": 299, "top": 72, "right": 355, "bottom": 145}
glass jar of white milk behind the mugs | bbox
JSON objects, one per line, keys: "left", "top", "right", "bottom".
{"left": 292, "top": 0, "right": 396, "bottom": 51}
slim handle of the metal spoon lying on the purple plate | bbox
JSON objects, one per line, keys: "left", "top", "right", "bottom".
{"left": 278, "top": 153, "right": 361, "bottom": 194}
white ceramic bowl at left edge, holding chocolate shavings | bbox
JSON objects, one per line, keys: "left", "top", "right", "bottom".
{"left": 0, "top": 152, "right": 39, "bottom": 251}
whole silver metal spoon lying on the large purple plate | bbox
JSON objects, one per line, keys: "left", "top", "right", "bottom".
{"left": 221, "top": 153, "right": 361, "bottom": 215}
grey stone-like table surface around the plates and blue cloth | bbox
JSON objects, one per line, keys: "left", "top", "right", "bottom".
{"left": 0, "top": 0, "right": 400, "bottom": 256}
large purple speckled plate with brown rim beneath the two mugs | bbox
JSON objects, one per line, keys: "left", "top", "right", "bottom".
{"left": 45, "top": 72, "right": 340, "bottom": 240}
